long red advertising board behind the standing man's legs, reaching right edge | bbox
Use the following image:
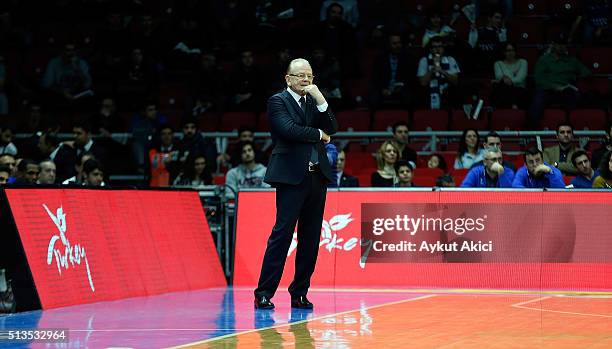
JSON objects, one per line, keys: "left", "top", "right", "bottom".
{"left": 234, "top": 191, "right": 612, "bottom": 290}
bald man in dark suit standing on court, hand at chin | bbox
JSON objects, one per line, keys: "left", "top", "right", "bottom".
{"left": 254, "top": 58, "right": 338, "bottom": 309}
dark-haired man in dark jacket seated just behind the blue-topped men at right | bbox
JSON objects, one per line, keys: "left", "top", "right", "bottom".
{"left": 542, "top": 123, "right": 580, "bottom": 176}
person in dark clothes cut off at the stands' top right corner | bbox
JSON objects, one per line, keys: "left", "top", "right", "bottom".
{"left": 569, "top": 0, "right": 612, "bottom": 45}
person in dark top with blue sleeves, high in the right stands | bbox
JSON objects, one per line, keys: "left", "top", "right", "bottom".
{"left": 468, "top": 10, "right": 507, "bottom": 76}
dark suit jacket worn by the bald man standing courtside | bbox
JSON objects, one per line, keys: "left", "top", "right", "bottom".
{"left": 264, "top": 90, "right": 338, "bottom": 186}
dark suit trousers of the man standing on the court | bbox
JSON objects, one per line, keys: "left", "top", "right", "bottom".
{"left": 255, "top": 169, "right": 327, "bottom": 298}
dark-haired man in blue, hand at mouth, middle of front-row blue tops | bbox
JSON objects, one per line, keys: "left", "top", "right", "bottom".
{"left": 512, "top": 147, "right": 565, "bottom": 188}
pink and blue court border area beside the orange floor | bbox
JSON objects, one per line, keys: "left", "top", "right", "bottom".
{"left": 0, "top": 288, "right": 422, "bottom": 348}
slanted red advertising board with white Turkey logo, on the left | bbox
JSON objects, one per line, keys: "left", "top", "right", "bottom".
{"left": 5, "top": 189, "right": 226, "bottom": 309}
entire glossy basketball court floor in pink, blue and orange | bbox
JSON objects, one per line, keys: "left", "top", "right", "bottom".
{"left": 0, "top": 288, "right": 612, "bottom": 349}
